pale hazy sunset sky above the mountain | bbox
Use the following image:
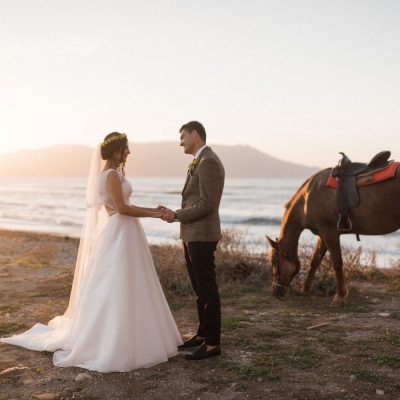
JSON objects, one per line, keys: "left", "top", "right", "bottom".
{"left": 0, "top": 0, "right": 400, "bottom": 167}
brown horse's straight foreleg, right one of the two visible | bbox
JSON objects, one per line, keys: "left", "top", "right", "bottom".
{"left": 321, "top": 232, "right": 349, "bottom": 305}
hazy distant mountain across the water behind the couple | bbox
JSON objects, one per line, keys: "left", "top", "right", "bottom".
{"left": 0, "top": 142, "right": 319, "bottom": 178}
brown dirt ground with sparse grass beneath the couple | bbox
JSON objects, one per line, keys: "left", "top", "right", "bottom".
{"left": 0, "top": 231, "right": 400, "bottom": 400}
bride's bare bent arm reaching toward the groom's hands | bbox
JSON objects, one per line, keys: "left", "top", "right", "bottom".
{"left": 107, "top": 172, "right": 163, "bottom": 218}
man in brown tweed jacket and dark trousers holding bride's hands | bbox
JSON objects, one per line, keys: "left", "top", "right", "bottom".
{"left": 163, "top": 121, "right": 225, "bottom": 360}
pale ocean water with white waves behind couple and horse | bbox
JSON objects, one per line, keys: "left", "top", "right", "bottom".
{"left": 0, "top": 177, "right": 400, "bottom": 267}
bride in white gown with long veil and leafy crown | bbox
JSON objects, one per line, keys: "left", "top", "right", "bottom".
{"left": 0, "top": 132, "right": 182, "bottom": 372}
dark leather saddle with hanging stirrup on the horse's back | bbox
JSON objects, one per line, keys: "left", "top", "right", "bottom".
{"left": 331, "top": 151, "right": 391, "bottom": 232}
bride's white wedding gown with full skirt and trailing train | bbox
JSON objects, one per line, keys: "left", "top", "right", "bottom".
{"left": 0, "top": 171, "right": 182, "bottom": 372}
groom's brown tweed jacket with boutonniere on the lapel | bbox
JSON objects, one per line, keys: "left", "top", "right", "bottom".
{"left": 176, "top": 147, "right": 225, "bottom": 242}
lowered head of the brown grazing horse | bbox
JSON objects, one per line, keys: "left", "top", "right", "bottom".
{"left": 267, "top": 236, "right": 300, "bottom": 299}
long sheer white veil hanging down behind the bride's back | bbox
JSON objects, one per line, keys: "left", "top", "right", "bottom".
{"left": 64, "top": 144, "right": 108, "bottom": 318}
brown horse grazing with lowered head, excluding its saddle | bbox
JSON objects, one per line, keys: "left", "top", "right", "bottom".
{"left": 268, "top": 168, "right": 400, "bottom": 304}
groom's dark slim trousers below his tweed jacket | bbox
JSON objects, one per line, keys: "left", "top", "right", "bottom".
{"left": 183, "top": 242, "right": 221, "bottom": 346}
